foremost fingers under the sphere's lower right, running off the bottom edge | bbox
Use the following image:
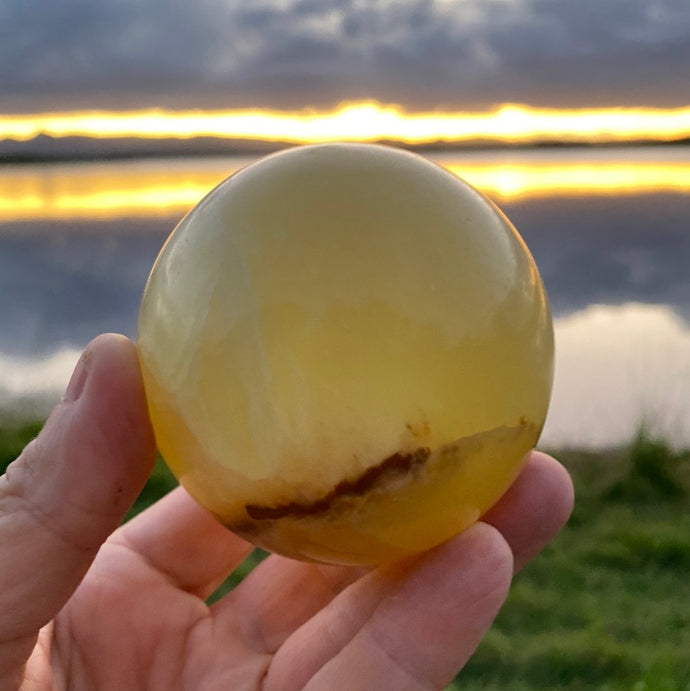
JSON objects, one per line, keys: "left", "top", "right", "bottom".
{"left": 265, "top": 523, "right": 513, "bottom": 690}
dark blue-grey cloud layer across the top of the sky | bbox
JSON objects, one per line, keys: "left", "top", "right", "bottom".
{"left": 0, "top": 0, "right": 690, "bottom": 111}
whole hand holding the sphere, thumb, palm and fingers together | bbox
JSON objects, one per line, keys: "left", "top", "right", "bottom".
{"left": 0, "top": 334, "right": 573, "bottom": 691}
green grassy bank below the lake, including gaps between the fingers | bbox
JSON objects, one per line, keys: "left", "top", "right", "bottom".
{"left": 0, "top": 424, "right": 690, "bottom": 691}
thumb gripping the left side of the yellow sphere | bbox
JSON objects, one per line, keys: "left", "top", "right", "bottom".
{"left": 0, "top": 334, "right": 155, "bottom": 678}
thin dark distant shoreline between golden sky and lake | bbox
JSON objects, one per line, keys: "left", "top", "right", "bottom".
{"left": 0, "top": 135, "right": 690, "bottom": 165}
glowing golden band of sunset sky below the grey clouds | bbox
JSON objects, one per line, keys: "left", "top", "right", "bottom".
{"left": 0, "top": 101, "right": 690, "bottom": 144}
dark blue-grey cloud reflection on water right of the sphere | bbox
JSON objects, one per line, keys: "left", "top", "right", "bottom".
{"left": 502, "top": 194, "right": 690, "bottom": 320}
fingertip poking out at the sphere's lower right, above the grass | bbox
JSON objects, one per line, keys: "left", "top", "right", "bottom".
{"left": 482, "top": 451, "right": 574, "bottom": 571}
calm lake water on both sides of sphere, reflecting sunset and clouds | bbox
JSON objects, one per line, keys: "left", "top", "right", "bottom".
{"left": 0, "top": 147, "right": 690, "bottom": 447}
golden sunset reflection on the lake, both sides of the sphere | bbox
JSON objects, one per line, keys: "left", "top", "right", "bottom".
{"left": 0, "top": 155, "right": 690, "bottom": 222}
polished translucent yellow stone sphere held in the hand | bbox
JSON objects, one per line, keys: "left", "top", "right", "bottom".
{"left": 138, "top": 144, "right": 553, "bottom": 564}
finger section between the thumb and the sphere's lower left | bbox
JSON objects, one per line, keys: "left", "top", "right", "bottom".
{"left": 110, "top": 487, "right": 253, "bottom": 599}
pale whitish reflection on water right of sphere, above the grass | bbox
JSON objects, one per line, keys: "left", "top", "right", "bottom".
{"left": 542, "top": 303, "right": 690, "bottom": 448}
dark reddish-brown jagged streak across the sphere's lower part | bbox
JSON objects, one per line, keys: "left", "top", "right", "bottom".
{"left": 245, "top": 447, "right": 431, "bottom": 521}
